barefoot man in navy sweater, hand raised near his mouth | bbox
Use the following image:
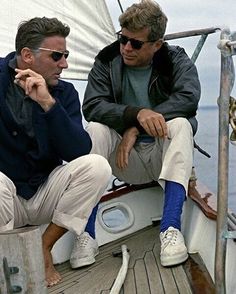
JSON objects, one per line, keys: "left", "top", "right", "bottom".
{"left": 0, "top": 17, "right": 111, "bottom": 286}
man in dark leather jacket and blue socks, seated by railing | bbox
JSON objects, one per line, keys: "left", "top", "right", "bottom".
{"left": 83, "top": 0, "right": 200, "bottom": 266}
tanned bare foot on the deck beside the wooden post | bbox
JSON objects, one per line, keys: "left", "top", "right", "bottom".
{"left": 43, "top": 248, "right": 61, "bottom": 287}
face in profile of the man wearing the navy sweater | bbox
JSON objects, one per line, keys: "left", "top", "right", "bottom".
{"left": 30, "top": 36, "right": 68, "bottom": 86}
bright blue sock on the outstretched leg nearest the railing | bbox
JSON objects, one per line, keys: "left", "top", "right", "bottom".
{"left": 160, "top": 181, "right": 186, "bottom": 232}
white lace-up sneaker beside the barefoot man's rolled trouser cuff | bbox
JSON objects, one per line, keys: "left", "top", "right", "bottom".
{"left": 70, "top": 232, "right": 99, "bottom": 268}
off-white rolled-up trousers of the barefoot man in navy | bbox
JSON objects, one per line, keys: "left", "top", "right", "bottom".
{"left": 0, "top": 154, "right": 111, "bottom": 235}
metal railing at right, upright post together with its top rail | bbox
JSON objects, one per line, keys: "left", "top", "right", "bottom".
{"left": 164, "top": 27, "right": 236, "bottom": 294}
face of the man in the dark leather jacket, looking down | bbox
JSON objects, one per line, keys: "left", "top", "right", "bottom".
{"left": 120, "top": 28, "right": 161, "bottom": 67}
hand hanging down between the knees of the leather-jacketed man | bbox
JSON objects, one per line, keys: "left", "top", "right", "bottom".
{"left": 116, "top": 127, "right": 139, "bottom": 169}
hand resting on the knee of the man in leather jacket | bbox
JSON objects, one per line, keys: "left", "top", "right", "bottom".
{"left": 137, "top": 108, "right": 167, "bottom": 138}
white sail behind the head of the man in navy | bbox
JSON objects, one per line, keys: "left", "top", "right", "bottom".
{"left": 0, "top": 0, "right": 115, "bottom": 80}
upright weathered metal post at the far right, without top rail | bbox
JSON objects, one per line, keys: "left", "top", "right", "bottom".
{"left": 215, "top": 28, "right": 236, "bottom": 294}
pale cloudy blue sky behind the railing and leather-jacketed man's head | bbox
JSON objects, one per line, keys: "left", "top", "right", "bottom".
{"left": 107, "top": 0, "right": 236, "bottom": 106}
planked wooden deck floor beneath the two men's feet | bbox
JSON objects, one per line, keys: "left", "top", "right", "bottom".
{"left": 49, "top": 226, "right": 214, "bottom": 294}
